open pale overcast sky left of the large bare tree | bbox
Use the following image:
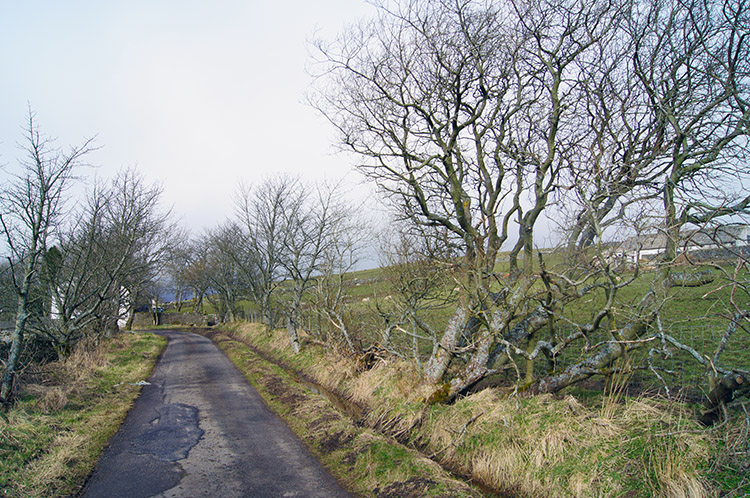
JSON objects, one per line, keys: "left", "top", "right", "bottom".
{"left": 0, "top": 0, "right": 374, "bottom": 231}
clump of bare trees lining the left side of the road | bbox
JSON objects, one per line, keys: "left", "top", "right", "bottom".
{"left": 0, "top": 111, "right": 171, "bottom": 402}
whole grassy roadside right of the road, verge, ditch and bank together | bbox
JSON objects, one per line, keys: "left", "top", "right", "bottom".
{"left": 203, "top": 324, "right": 750, "bottom": 497}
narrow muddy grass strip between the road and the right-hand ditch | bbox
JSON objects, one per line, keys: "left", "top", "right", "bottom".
{"left": 201, "top": 330, "right": 481, "bottom": 498}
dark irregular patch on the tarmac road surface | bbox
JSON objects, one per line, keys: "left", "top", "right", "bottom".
{"left": 132, "top": 403, "right": 203, "bottom": 462}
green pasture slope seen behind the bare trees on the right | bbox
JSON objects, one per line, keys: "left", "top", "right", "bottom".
{"left": 254, "top": 254, "right": 750, "bottom": 399}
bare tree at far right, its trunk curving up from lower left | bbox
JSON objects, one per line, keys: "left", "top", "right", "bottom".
{"left": 541, "top": 1, "right": 750, "bottom": 396}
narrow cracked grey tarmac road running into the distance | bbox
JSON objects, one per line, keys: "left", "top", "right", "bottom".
{"left": 81, "top": 331, "right": 350, "bottom": 498}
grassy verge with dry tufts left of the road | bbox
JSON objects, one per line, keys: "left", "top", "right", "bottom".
{"left": 0, "top": 333, "right": 166, "bottom": 498}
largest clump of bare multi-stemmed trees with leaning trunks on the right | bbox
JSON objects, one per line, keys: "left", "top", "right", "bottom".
{"left": 313, "top": 0, "right": 750, "bottom": 399}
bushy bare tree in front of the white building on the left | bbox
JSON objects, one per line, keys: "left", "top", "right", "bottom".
{"left": 33, "top": 169, "right": 171, "bottom": 348}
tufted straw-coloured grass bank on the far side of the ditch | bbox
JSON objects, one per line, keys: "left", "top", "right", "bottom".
{"left": 217, "top": 324, "right": 750, "bottom": 497}
